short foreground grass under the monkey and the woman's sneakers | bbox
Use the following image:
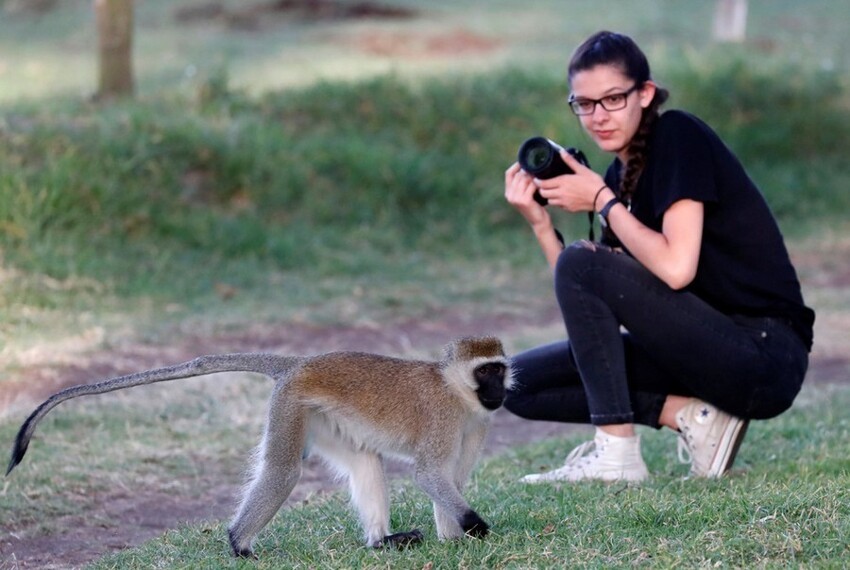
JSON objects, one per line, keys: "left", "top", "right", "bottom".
{"left": 0, "top": 378, "right": 850, "bottom": 568}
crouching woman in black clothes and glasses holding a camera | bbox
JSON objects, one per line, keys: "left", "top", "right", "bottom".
{"left": 505, "top": 32, "right": 814, "bottom": 483}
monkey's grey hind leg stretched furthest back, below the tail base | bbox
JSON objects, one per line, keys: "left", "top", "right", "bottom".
{"left": 228, "top": 398, "right": 306, "bottom": 557}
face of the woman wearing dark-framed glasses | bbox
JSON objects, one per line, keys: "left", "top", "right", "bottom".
{"left": 570, "top": 65, "right": 655, "bottom": 161}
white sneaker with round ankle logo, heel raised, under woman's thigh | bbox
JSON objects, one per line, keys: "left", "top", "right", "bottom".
{"left": 676, "top": 398, "right": 749, "bottom": 478}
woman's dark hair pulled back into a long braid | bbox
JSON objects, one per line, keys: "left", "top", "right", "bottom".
{"left": 567, "top": 31, "right": 670, "bottom": 204}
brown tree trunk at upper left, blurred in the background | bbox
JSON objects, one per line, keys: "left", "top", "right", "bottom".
{"left": 94, "top": 0, "right": 134, "bottom": 99}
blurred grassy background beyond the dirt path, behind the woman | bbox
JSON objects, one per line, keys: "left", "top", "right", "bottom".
{"left": 0, "top": 0, "right": 850, "bottom": 330}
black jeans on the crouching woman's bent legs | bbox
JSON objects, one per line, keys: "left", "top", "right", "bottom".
{"left": 505, "top": 244, "right": 808, "bottom": 427}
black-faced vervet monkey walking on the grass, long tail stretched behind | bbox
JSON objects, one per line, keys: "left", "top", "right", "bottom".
{"left": 6, "top": 337, "right": 513, "bottom": 557}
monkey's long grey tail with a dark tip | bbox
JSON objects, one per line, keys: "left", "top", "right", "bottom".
{"left": 6, "top": 353, "right": 301, "bottom": 476}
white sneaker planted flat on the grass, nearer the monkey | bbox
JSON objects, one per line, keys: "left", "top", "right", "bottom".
{"left": 520, "top": 428, "right": 649, "bottom": 483}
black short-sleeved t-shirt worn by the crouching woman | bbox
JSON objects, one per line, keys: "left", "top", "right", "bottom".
{"left": 605, "top": 110, "right": 815, "bottom": 350}
